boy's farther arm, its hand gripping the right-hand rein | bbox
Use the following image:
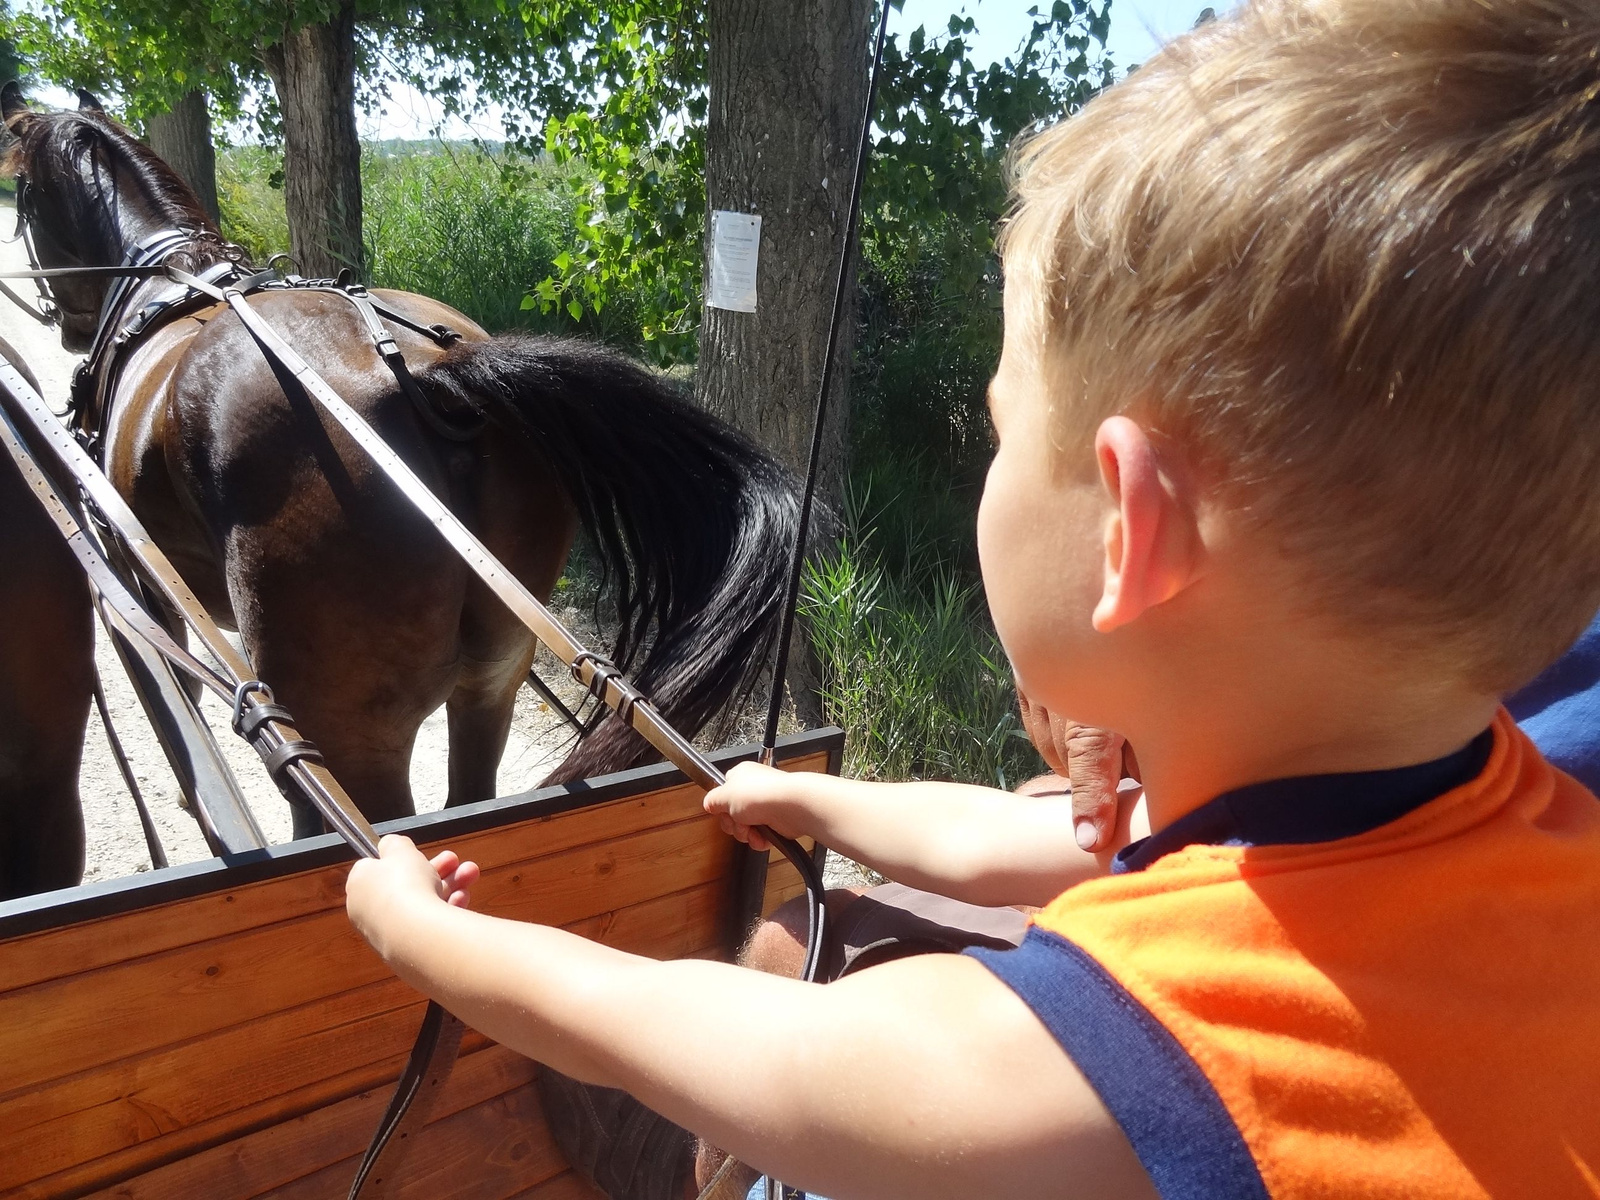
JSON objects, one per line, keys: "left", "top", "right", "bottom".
{"left": 706, "top": 763, "right": 1149, "bottom": 906}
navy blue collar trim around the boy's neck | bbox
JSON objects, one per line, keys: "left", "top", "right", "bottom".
{"left": 1110, "top": 730, "right": 1494, "bottom": 875}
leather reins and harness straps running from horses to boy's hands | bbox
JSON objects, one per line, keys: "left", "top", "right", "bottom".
{"left": 0, "top": 200, "right": 827, "bottom": 1200}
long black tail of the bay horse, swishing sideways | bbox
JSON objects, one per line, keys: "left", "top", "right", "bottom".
{"left": 418, "top": 336, "right": 800, "bottom": 782}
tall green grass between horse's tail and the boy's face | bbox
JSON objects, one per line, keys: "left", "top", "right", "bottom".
{"left": 802, "top": 473, "right": 1045, "bottom": 787}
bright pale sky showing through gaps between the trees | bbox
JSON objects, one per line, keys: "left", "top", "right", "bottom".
{"left": 35, "top": 0, "right": 1230, "bottom": 141}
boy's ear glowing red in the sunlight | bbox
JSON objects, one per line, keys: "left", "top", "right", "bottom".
{"left": 1094, "top": 416, "right": 1198, "bottom": 634}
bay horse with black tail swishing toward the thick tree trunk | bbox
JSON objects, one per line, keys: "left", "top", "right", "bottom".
{"left": 0, "top": 85, "right": 798, "bottom": 837}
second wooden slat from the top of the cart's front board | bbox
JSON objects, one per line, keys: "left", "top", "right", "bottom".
{"left": 0, "top": 821, "right": 731, "bottom": 1101}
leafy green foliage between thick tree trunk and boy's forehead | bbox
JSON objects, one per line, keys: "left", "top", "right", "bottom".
{"left": 856, "top": 0, "right": 1112, "bottom": 488}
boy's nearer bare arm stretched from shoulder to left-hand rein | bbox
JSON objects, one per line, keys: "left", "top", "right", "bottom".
{"left": 349, "top": 837, "right": 1154, "bottom": 1200}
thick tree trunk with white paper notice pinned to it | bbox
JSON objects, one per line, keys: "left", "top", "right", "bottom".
{"left": 694, "top": 0, "right": 872, "bottom": 506}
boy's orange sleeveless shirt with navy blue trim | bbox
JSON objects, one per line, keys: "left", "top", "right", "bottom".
{"left": 970, "top": 712, "right": 1600, "bottom": 1200}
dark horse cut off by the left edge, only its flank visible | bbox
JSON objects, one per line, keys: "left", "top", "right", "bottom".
{"left": 0, "top": 339, "right": 94, "bottom": 901}
